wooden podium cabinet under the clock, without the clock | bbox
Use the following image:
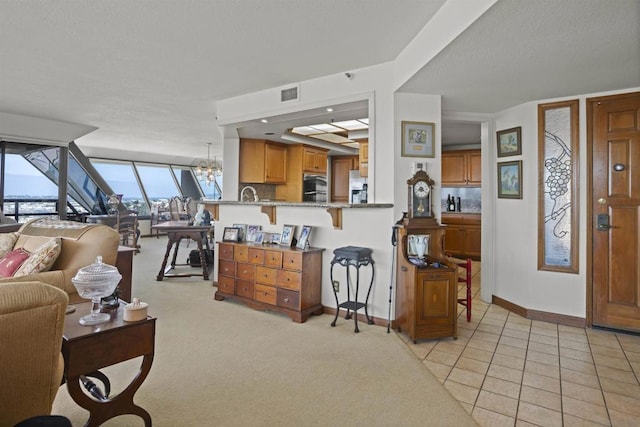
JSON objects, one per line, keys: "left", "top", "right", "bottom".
{"left": 394, "top": 218, "right": 458, "bottom": 343}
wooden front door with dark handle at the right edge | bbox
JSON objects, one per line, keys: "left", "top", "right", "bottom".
{"left": 587, "top": 92, "right": 640, "bottom": 331}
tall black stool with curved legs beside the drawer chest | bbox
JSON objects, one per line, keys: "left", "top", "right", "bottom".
{"left": 330, "top": 246, "right": 375, "bottom": 333}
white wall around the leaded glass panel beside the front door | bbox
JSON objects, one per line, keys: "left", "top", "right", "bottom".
{"left": 492, "top": 88, "right": 638, "bottom": 317}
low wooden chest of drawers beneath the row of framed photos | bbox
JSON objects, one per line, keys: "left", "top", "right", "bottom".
{"left": 215, "top": 242, "right": 324, "bottom": 323}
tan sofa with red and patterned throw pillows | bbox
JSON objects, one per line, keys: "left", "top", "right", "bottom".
{"left": 0, "top": 219, "right": 120, "bottom": 303}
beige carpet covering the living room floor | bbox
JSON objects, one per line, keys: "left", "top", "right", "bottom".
{"left": 54, "top": 237, "right": 476, "bottom": 427}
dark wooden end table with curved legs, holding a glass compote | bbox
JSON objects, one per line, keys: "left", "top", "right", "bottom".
{"left": 62, "top": 302, "right": 156, "bottom": 427}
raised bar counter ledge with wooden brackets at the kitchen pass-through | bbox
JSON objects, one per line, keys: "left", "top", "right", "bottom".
{"left": 199, "top": 199, "right": 393, "bottom": 229}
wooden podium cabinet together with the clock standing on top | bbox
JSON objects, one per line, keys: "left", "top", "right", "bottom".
{"left": 394, "top": 170, "right": 458, "bottom": 343}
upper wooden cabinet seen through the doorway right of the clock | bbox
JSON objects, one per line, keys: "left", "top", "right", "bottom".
{"left": 442, "top": 150, "right": 482, "bottom": 187}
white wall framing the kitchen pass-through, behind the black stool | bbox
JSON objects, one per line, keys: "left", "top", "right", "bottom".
{"left": 215, "top": 64, "right": 402, "bottom": 319}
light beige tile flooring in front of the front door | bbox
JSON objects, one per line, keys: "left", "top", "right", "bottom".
{"left": 400, "top": 262, "right": 640, "bottom": 427}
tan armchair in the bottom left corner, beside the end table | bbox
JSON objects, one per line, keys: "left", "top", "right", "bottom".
{"left": 0, "top": 282, "right": 69, "bottom": 426}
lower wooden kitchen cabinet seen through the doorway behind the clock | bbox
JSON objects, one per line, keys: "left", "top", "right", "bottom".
{"left": 442, "top": 213, "right": 482, "bottom": 260}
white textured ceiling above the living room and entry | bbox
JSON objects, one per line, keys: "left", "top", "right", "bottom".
{"left": 0, "top": 0, "right": 640, "bottom": 162}
